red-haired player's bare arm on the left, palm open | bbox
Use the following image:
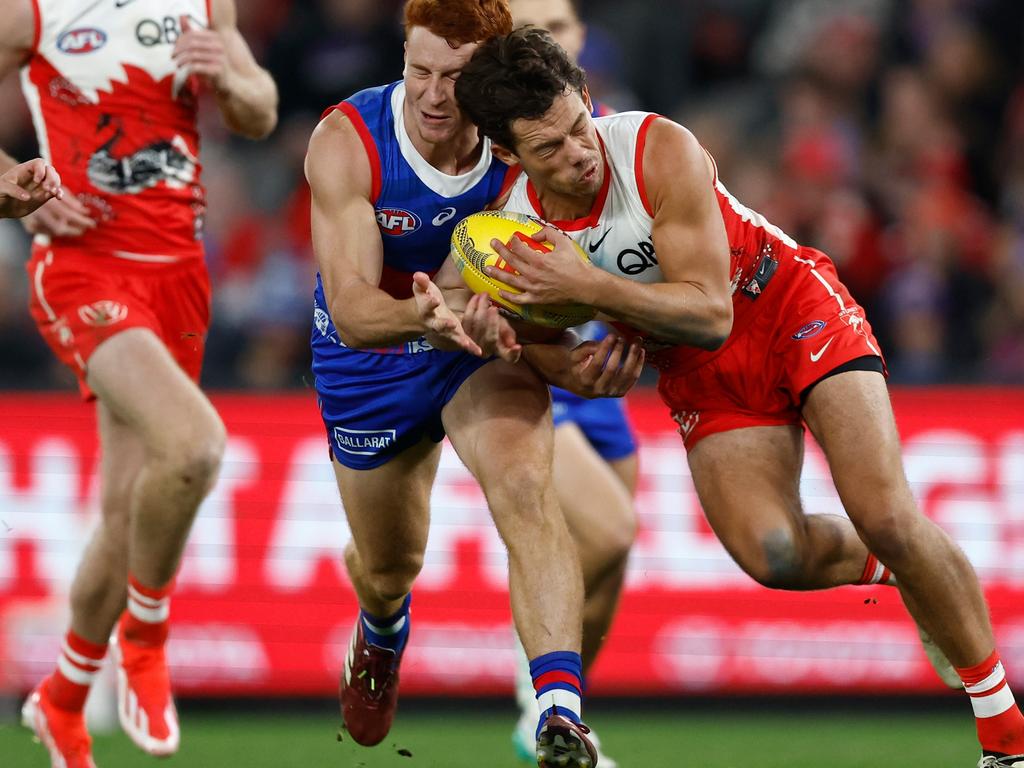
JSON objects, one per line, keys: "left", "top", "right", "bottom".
{"left": 305, "top": 112, "right": 480, "bottom": 354}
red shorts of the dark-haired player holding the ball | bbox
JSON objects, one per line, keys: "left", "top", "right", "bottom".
{"left": 657, "top": 248, "right": 885, "bottom": 450}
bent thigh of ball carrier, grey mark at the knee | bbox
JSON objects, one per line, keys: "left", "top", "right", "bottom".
{"left": 688, "top": 426, "right": 803, "bottom": 571}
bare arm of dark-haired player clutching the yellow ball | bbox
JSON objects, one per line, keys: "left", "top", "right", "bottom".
{"left": 492, "top": 119, "right": 732, "bottom": 349}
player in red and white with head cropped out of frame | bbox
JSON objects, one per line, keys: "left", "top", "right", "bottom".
{"left": 0, "top": 0, "right": 276, "bottom": 768}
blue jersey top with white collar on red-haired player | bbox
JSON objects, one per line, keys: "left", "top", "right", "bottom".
{"left": 321, "top": 81, "right": 508, "bottom": 306}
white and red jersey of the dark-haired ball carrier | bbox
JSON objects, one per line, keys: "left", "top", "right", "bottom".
{"left": 503, "top": 112, "right": 799, "bottom": 364}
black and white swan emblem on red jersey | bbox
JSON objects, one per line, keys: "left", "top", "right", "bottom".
{"left": 88, "top": 116, "right": 199, "bottom": 195}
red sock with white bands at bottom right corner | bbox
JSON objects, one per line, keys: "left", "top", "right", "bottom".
{"left": 956, "top": 650, "right": 1024, "bottom": 755}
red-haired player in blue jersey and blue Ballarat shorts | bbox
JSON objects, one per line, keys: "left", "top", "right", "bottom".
{"left": 306, "top": 0, "right": 642, "bottom": 768}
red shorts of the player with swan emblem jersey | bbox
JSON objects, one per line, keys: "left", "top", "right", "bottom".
{"left": 27, "top": 246, "right": 210, "bottom": 399}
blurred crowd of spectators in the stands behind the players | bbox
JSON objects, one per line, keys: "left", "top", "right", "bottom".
{"left": 0, "top": 0, "right": 1024, "bottom": 389}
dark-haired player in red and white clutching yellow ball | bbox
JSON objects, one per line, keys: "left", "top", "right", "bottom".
{"left": 456, "top": 29, "right": 1024, "bottom": 768}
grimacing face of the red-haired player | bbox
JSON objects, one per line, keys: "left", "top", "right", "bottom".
{"left": 404, "top": 27, "right": 477, "bottom": 143}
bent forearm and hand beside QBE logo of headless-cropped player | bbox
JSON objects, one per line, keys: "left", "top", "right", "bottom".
{"left": 171, "top": 0, "right": 278, "bottom": 138}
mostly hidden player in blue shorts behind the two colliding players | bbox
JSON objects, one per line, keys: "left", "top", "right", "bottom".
{"left": 509, "top": 0, "right": 637, "bottom": 768}
